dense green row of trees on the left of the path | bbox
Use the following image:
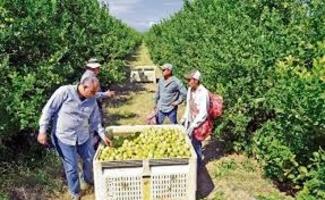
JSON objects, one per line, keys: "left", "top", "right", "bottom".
{"left": 0, "top": 0, "right": 142, "bottom": 159}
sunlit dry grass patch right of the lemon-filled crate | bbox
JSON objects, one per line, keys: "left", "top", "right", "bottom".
{"left": 207, "top": 155, "right": 293, "bottom": 200}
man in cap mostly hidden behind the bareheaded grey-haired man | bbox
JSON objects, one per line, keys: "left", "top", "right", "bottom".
{"left": 80, "top": 58, "right": 115, "bottom": 150}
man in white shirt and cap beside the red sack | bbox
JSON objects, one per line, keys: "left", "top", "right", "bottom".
{"left": 182, "top": 70, "right": 209, "bottom": 167}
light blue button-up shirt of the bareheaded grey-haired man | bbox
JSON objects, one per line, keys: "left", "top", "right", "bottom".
{"left": 39, "top": 85, "right": 105, "bottom": 145}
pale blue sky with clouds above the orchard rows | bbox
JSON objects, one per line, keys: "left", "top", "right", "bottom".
{"left": 101, "top": 0, "right": 183, "bottom": 32}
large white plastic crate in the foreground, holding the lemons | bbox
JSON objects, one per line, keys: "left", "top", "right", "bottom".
{"left": 93, "top": 125, "right": 197, "bottom": 200}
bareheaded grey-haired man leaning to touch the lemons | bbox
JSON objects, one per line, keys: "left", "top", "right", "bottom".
{"left": 37, "top": 77, "right": 111, "bottom": 199}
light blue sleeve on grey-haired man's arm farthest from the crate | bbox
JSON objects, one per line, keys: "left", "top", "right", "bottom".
{"left": 39, "top": 86, "right": 66, "bottom": 133}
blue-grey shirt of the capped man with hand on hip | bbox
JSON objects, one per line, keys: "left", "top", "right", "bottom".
{"left": 155, "top": 76, "right": 186, "bottom": 112}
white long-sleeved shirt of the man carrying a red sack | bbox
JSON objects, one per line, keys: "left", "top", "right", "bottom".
{"left": 183, "top": 84, "right": 209, "bottom": 129}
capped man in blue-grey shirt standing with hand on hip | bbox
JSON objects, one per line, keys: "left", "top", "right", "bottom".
{"left": 155, "top": 63, "right": 186, "bottom": 124}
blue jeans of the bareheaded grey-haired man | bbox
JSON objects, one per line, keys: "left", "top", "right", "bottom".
{"left": 52, "top": 134, "right": 95, "bottom": 195}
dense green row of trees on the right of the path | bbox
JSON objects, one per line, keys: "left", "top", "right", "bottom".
{"left": 145, "top": 0, "right": 325, "bottom": 199}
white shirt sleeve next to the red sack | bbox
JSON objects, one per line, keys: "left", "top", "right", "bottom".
{"left": 191, "top": 89, "right": 209, "bottom": 128}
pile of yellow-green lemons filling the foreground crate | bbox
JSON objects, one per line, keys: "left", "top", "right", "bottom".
{"left": 99, "top": 128, "right": 191, "bottom": 160}
